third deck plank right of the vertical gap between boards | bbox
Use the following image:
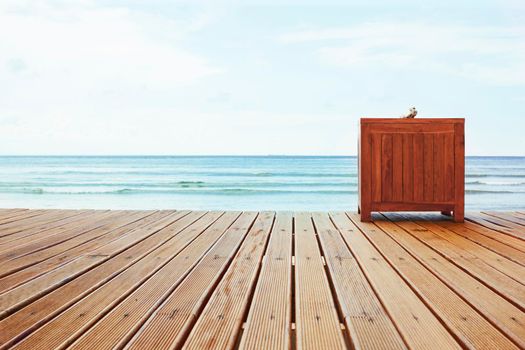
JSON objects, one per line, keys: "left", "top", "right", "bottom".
{"left": 330, "top": 213, "right": 461, "bottom": 349}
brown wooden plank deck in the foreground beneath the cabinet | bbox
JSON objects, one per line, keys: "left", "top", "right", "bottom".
{"left": 0, "top": 209, "right": 525, "bottom": 349}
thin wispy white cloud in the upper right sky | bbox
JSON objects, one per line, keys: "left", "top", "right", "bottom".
{"left": 280, "top": 22, "right": 525, "bottom": 85}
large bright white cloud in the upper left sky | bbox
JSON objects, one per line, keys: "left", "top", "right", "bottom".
{"left": 0, "top": 1, "right": 220, "bottom": 105}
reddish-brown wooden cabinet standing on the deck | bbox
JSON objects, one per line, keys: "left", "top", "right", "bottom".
{"left": 359, "top": 118, "right": 465, "bottom": 222}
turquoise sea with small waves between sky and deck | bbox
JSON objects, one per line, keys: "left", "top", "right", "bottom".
{"left": 0, "top": 156, "right": 525, "bottom": 210}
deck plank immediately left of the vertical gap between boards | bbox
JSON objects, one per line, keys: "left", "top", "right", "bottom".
{"left": 239, "top": 213, "right": 293, "bottom": 349}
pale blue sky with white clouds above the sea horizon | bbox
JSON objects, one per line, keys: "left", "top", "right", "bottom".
{"left": 0, "top": 0, "right": 525, "bottom": 156}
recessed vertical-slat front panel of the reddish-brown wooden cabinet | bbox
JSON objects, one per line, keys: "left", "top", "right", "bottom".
{"left": 370, "top": 130, "right": 454, "bottom": 203}
